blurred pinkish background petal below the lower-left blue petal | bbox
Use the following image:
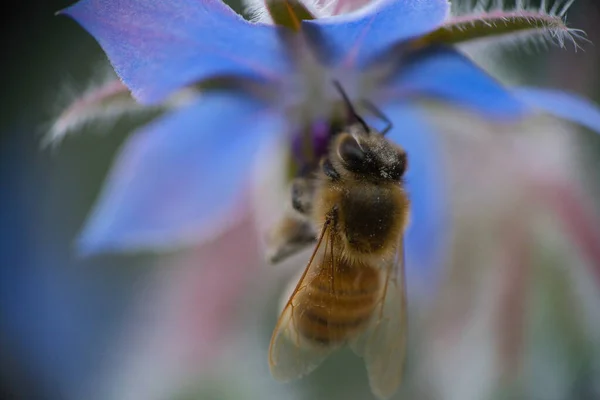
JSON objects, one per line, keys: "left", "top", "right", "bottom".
{"left": 95, "top": 209, "right": 262, "bottom": 400}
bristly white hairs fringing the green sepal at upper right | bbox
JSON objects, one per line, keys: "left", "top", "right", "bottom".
{"left": 446, "top": 0, "right": 589, "bottom": 52}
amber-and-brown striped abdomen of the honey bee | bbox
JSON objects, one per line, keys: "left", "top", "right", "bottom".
{"left": 294, "top": 260, "right": 380, "bottom": 345}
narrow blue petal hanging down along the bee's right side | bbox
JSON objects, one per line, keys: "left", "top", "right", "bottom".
{"left": 382, "top": 105, "right": 448, "bottom": 294}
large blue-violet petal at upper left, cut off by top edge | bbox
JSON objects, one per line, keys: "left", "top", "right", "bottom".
{"left": 63, "top": 0, "right": 290, "bottom": 103}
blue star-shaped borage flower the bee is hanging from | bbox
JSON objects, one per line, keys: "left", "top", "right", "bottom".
{"left": 64, "top": 0, "right": 600, "bottom": 275}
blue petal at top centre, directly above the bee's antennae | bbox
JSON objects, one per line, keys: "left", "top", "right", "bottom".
{"left": 302, "top": 0, "right": 450, "bottom": 66}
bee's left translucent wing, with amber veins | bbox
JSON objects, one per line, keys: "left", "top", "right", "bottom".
{"left": 269, "top": 212, "right": 337, "bottom": 381}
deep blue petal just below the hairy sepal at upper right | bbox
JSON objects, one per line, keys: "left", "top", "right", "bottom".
{"left": 384, "top": 46, "right": 528, "bottom": 120}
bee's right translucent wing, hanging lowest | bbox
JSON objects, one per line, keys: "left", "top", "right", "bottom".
{"left": 350, "top": 237, "right": 407, "bottom": 399}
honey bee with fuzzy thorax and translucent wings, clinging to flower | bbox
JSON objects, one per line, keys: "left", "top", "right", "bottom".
{"left": 269, "top": 82, "right": 410, "bottom": 399}
